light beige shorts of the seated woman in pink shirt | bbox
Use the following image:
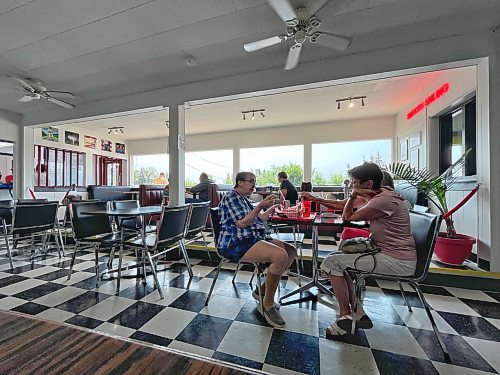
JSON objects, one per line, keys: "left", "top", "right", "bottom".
{"left": 321, "top": 252, "right": 417, "bottom": 276}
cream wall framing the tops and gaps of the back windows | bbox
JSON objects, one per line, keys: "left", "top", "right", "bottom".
{"left": 129, "top": 116, "right": 395, "bottom": 181}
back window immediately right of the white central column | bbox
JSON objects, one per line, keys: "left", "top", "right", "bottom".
{"left": 185, "top": 150, "right": 233, "bottom": 186}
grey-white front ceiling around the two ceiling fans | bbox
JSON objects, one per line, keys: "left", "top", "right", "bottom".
{"left": 0, "top": 0, "right": 500, "bottom": 121}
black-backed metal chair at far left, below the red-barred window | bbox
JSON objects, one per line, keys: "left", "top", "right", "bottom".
{"left": 3, "top": 201, "right": 64, "bottom": 259}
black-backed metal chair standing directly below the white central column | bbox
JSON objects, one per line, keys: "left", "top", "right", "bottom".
{"left": 127, "top": 205, "right": 193, "bottom": 299}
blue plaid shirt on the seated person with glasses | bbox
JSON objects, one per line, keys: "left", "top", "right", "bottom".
{"left": 217, "top": 190, "right": 269, "bottom": 249}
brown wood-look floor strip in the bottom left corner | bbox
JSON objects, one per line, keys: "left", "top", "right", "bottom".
{"left": 0, "top": 311, "right": 255, "bottom": 375}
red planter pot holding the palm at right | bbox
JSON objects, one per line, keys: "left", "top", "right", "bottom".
{"left": 434, "top": 232, "right": 476, "bottom": 265}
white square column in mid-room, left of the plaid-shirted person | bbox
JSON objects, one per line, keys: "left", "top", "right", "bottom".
{"left": 168, "top": 105, "right": 186, "bottom": 206}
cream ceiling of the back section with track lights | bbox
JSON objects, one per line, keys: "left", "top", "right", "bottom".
{"left": 53, "top": 67, "right": 475, "bottom": 140}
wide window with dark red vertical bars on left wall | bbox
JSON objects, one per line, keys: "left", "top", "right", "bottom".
{"left": 34, "top": 145, "right": 85, "bottom": 187}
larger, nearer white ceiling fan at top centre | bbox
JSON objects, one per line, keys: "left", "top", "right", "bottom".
{"left": 243, "top": 0, "right": 352, "bottom": 70}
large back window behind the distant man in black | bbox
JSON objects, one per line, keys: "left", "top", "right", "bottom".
{"left": 240, "top": 145, "right": 304, "bottom": 186}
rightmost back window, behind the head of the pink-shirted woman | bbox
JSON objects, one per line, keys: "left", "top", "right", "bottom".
{"left": 312, "top": 139, "right": 392, "bottom": 186}
